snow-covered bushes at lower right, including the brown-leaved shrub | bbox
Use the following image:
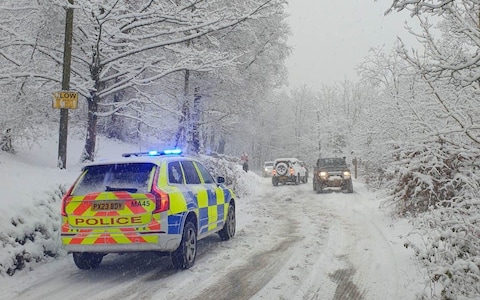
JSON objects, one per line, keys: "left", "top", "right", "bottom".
{"left": 385, "top": 142, "right": 480, "bottom": 299}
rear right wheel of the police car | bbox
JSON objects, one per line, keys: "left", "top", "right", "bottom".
{"left": 171, "top": 221, "right": 197, "bottom": 269}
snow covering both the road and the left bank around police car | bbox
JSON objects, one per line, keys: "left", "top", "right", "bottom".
{"left": 0, "top": 137, "right": 424, "bottom": 300}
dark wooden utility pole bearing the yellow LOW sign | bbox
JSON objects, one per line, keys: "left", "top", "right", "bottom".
{"left": 57, "top": 0, "right": 73, "bottom": 169}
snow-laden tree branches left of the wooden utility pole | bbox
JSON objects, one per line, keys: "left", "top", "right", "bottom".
{"left": 0, "top": 0, "right": 64, "bottom": 143}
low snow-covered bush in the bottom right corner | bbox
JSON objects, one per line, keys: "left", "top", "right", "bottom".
{"left": 411, "top": 195, "right": 480, "bottom": 299}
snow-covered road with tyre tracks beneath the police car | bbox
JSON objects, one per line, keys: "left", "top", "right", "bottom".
{"left": 0, "top": 178, "right": 422, "bottom": 300}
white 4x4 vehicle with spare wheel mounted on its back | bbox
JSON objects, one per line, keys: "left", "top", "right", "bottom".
{"left": 272, "top": 158, "right": 307, "bottom": 186}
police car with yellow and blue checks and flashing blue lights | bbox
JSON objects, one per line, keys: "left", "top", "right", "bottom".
{"left": 61, "top": 150, "right": 236, "bottom": 269}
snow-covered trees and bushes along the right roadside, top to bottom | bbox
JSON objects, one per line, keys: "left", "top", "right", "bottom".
{"left": 377, "top": 0, "right": 480, "bottom": 299}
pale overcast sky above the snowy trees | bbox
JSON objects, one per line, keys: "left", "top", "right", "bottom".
{"left": 287, "top": 0, "right": 413, "bottom": 89}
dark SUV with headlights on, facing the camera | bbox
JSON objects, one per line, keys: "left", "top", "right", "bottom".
{"left": 313, "top": 157, "right": 353, "bottom": 193}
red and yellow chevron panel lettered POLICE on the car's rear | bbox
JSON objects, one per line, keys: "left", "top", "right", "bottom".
{"left": 61, "top": 192, "right": 162, "bottom": 245}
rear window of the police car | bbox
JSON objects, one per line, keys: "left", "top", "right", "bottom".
{"left": 72, "top": 163, "right": 155, "bottom": 196}
